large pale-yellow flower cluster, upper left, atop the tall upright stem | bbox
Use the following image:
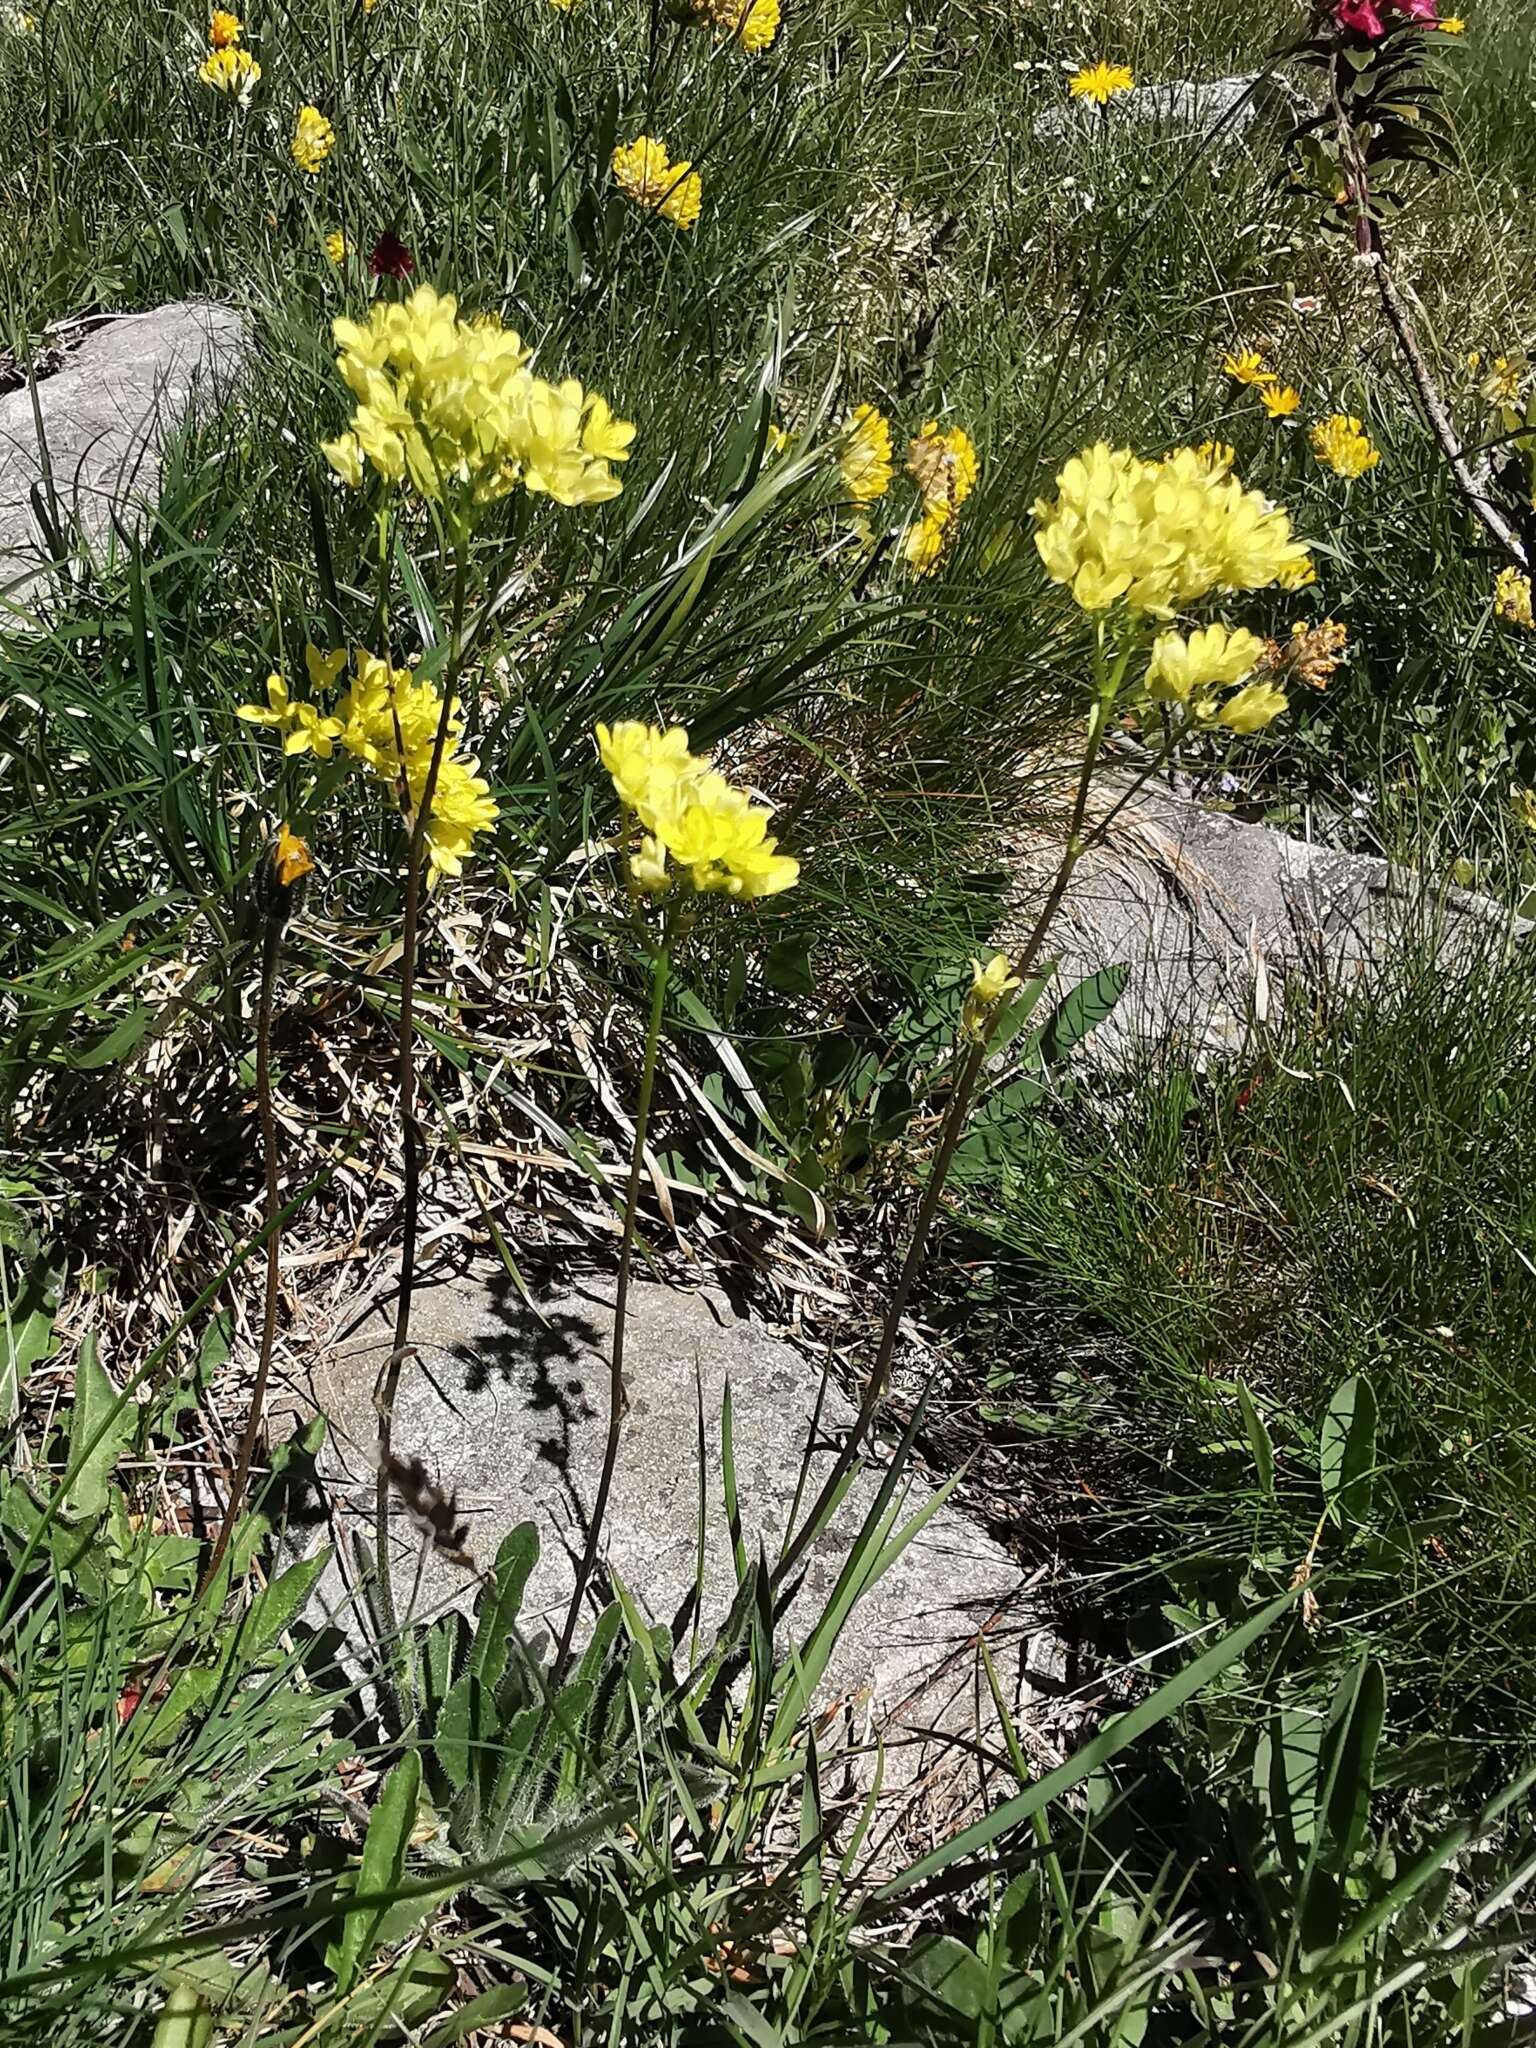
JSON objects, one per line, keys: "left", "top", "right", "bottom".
{"left": 324, "top": 285, "right": 635, "bottom": 506}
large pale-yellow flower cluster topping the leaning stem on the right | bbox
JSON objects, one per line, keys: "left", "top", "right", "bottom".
{"left": 1034, "top": 442, "right": 1313, "bottom": 618}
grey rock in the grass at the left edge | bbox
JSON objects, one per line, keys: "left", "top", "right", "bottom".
{"left": 0, "top": 301, "right": 250, "bottom": 616}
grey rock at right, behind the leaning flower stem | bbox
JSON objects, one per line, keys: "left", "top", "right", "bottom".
{"left": 997, "top": 786, "right": 1530, "bottom": 1067}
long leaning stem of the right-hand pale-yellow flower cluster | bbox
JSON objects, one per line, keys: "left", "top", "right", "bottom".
{"left": 774, "top": 633, "right": 1133, "bottom": 1587}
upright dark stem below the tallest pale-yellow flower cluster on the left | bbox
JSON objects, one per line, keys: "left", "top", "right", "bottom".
{"left": 373, "top": 535, "right": 469, "bottom": 1663}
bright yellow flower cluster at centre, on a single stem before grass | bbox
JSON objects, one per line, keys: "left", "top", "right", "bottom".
{"left": 596, "top": 719, "right": 801, "bottom": 899}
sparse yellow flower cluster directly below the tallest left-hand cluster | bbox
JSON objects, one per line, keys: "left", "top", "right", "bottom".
{"left": 240, "top": 647, "right": 500, "bottom": 883}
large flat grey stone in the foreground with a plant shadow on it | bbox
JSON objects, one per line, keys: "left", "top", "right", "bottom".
{"left": 309, "top": 1274, "right": 1049, "bottom": 1769}
